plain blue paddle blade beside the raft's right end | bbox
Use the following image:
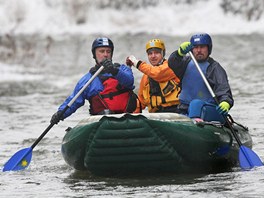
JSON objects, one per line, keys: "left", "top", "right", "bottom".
{"left": 239, "top": 146, "right": 263, "bottom": 169}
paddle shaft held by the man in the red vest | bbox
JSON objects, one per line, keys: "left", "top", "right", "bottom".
{"left": 31, "top": 66, "right": 104, "bottom": 150}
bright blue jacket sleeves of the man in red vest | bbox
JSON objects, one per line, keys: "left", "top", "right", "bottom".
{"left": 59, "top": 64, "right": 135, "bottom": 118}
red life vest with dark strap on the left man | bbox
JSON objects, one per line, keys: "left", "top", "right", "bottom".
{"left": 90, "top": 77, "right": 132, "bottom": 115}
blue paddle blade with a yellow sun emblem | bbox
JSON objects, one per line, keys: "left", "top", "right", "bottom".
{"left": 3, "top": 147, "right": 32, "bottom": 172}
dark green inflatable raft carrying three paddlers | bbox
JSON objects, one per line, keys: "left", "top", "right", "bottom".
{"left": 62, "top": 113, "right": 252, "bottom": 175}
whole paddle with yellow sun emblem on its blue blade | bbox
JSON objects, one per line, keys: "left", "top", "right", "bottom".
{"left": 3, "top": 66, "right": 104, "bottom": 172}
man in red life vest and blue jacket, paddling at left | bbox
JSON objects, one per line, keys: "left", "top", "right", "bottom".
{"left": 50, "top": 37, "right": 137, "bottom": 124}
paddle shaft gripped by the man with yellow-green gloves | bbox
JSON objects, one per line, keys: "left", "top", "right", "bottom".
{"left": 189, "top": 51, "right": 242, "bottom": 147}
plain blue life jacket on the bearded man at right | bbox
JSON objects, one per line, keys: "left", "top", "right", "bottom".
{"left": 179, "top": 60, "right": 214, "bottom": 105}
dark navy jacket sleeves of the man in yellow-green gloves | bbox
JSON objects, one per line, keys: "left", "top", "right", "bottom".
{"left": 168, "top": 50, "right": 234, "bottom": 108}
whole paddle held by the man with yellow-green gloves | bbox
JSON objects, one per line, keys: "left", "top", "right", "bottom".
{"left": 189, "top": 51, "right": 263, "bottom": 169}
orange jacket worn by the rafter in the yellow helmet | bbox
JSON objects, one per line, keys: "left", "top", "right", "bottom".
{"left": 135, "top": 60, "right": 180, "bottom": 113}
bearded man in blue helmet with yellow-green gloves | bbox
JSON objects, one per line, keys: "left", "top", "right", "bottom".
{"left": 168, "top": 33, "right": 234, "bottom": 122}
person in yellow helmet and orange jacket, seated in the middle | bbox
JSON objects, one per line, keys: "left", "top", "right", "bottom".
{"left": 126, "top": 39, "right": 180, "bottom": 113}
